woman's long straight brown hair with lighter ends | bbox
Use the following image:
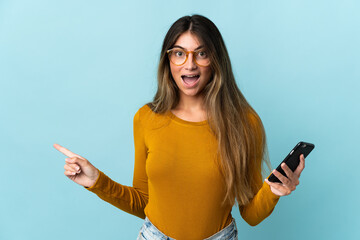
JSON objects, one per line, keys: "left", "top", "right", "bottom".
{"left": 148, "top": 15, "right": 270, "bottom": 206}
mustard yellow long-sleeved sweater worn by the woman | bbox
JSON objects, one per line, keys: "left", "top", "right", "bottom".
{"left": 87, "top": 105, "right": 279, "bottom": 240}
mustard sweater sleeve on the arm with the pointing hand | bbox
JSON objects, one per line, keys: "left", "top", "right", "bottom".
{"left": 86, "top": 110, "right": 148, "bottom": 219}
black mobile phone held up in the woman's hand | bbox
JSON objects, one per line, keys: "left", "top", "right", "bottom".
{"left": 268, "top": 142, "right": 315, "bottom": 183}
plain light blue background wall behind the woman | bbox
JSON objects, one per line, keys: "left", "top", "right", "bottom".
{"left": 0, "top": 0, "right": 360, "bottom": 240}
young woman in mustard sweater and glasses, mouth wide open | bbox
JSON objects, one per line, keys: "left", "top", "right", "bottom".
{"left": 54, "top": 15, "right": 305, "bottom": 240}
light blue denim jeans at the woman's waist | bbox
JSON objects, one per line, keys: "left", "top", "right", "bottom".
{"left": 137, "top": 217, "right": 238, "bottom": 240}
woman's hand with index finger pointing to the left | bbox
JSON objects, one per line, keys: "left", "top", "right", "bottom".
{"left": 53, "top": 144, "right": 99, "bottom": 187}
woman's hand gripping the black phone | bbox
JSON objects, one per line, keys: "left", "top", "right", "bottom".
{"left": 265, "top": 154, "right": 305, "bottom": 196}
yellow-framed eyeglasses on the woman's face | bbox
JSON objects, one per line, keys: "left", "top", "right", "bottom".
{"left": 166, "top": 48, "right": 210, "bottom": 67}
